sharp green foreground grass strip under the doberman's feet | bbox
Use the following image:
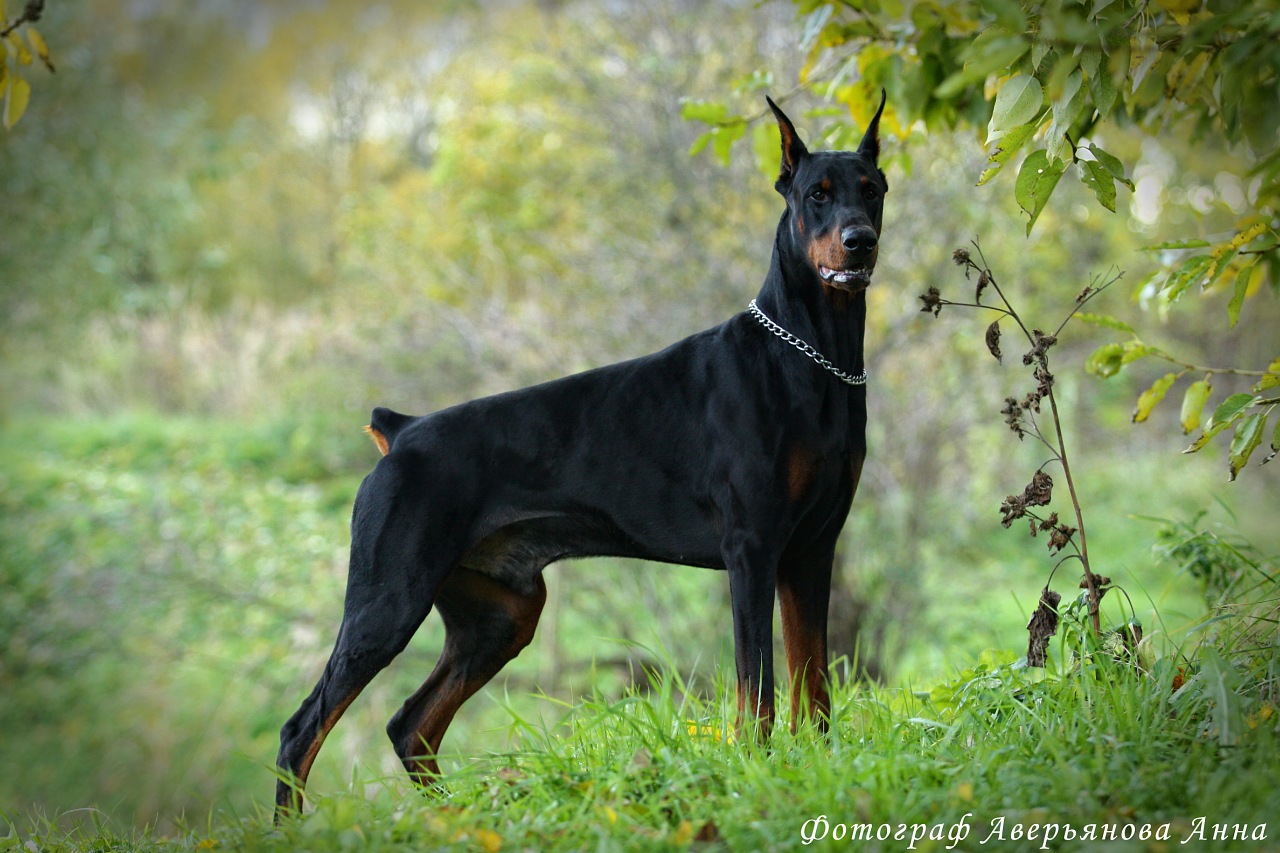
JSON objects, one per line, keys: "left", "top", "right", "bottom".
{"left": 0, "top": 661, "right": 1280, "bottom": 850}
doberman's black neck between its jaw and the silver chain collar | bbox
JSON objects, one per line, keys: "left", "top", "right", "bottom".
{"left": 756, "top": 211, "right": 867, "bottom": 384}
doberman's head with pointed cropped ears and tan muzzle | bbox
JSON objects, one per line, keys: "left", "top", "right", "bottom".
{"left": 765, "top": 91, "right": 888, "bottom": 292}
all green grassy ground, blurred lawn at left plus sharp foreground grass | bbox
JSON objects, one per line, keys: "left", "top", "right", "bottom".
{"left": 0, "top": 418, "right": 1280, "bottom": 850}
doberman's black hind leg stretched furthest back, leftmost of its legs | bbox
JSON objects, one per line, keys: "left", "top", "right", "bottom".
{"left": 275, "top": 457, "right": 457, "bottom": 820}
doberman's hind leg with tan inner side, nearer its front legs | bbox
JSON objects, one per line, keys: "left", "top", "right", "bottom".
{"left": 387, "top": 569, "right": 547, "bottom": 784}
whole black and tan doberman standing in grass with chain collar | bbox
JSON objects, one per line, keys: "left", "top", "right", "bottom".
{"left": 276, "top": 91, "right": 888, "bottom": 816}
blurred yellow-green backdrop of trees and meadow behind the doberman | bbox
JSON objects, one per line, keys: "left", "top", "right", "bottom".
{"left": 0, "top": 0, "right": 1277, "bottom": 822}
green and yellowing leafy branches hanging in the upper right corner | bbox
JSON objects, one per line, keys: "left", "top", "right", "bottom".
{"left": 685, "top": 0, "right": 1280, "bottom": 480}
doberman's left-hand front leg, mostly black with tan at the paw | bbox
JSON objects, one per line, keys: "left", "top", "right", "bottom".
{"left": 724, "top": 534, "right": 777, "bottom": 743}
